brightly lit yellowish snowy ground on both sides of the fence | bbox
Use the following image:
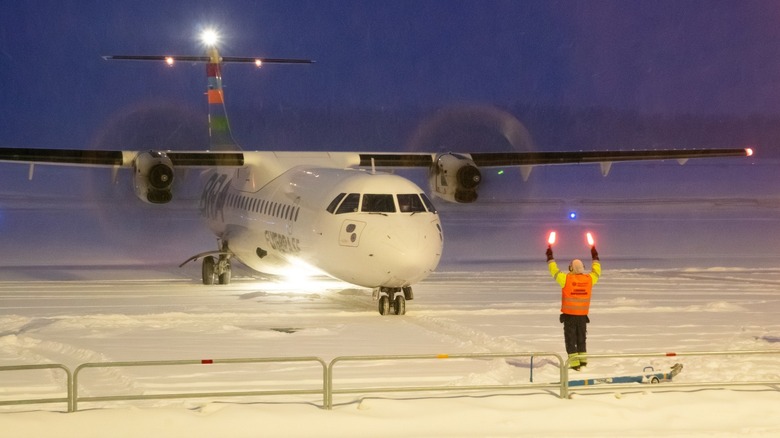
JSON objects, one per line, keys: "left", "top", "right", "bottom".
{"left": 0, "top": 266, "right": 780, "bottom": 436}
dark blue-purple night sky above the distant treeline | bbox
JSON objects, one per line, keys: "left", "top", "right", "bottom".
{"left": 0, "top": 0, "right": 780, "bottom": 147}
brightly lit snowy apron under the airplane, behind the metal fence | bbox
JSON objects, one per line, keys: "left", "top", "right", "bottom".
{"left": 0, "top": 263, "right": 780, "bottom": 405}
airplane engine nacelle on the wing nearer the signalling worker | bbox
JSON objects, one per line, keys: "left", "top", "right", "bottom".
{"left": 429, "top": 152, "right": 482, "bottom": 203}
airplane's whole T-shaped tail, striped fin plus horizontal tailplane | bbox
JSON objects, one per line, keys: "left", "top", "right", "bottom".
{"left": 103, "top": 51, "right": 314, "bottom": 151}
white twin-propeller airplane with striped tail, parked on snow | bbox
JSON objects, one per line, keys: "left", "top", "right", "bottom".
{"left": 0, "top": 36, "right": 753, "bottom": 315}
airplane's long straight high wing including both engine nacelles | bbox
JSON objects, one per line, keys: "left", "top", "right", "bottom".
{"left": 0, "top": 148, "right": 753, "bottom": 204}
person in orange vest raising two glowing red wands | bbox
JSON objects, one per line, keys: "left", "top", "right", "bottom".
{"left": 547, "top": 245, "right": 601, "bottom": 371}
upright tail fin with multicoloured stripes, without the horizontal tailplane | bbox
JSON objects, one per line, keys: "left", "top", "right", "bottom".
{"left": 206, "top": 47, "right": 241, "bottom": 151}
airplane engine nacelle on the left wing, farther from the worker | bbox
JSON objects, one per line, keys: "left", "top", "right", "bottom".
{"left": 133, "top": 151, "right": 173, "bottom": 204}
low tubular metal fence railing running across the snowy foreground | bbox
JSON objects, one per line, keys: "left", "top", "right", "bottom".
{"left": 0, "top": 349, "right": 780, "bottom": 412}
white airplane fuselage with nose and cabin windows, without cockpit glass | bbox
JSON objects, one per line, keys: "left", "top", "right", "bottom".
{"left": 201, "top": 157, "right": 443, "bottom": 288}
